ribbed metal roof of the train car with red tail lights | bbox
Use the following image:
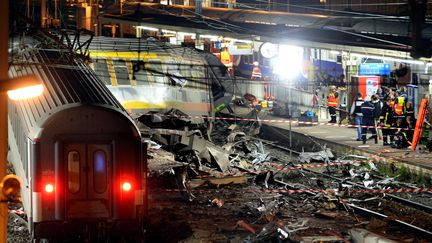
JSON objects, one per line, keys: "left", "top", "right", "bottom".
{"left": 9, "top": 49, "right": 128, "bottom": 135}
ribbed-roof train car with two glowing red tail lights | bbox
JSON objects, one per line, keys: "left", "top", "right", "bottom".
{"left": 8, "top": 50, "right": 147, "bottom": 242}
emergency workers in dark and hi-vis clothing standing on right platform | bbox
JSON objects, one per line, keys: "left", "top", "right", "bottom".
{"left": 327, "top": 87, "right": 415, "bottom": 148}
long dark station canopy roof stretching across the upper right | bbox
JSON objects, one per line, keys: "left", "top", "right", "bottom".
{"left": 100, "top": 3, "right": 432, "bottom": 58}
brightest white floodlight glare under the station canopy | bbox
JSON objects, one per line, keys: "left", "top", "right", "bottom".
{"left": 273, "top": 45, "right": 303, "bottom": 79}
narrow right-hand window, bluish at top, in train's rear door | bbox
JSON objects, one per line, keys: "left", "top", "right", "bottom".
{"left": 93, "top": 150, "right": 107, "bottom": 193}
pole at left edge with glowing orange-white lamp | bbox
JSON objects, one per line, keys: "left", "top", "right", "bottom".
{"left": 0, "top": 0, "right": 43, "bottom": 243}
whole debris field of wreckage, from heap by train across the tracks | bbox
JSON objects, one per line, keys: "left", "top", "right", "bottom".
{"left": 138, "top": 110, "right": 432, "bottom": 242}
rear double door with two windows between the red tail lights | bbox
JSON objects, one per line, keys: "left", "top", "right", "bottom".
{"left": 64, "top": 144, "right": 112, "bottom": 219}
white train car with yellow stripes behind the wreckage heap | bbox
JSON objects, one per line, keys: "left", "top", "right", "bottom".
{"left": 80, "top": 36, "right": 234, "bottom": 115}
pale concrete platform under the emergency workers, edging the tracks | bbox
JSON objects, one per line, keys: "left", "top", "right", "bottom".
{"left": 234, "top": 106, "right": 432, "bottom": 175}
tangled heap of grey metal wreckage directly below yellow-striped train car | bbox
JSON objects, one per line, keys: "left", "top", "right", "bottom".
{"left": 138, "top": 110, "right": 272, "bottom": 199}
